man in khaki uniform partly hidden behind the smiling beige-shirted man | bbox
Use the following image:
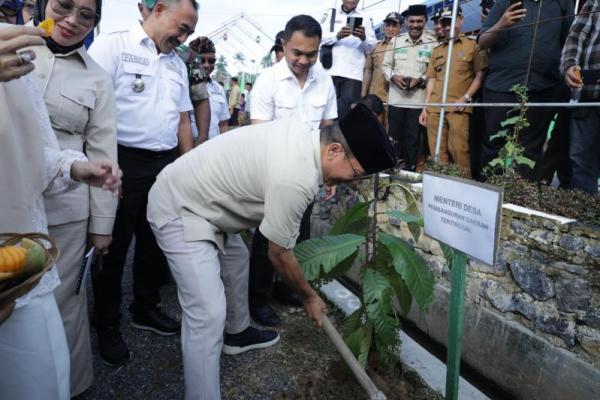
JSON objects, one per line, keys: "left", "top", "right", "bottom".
{"left": 360, "top": 12, "right": 404, "bottom": 127}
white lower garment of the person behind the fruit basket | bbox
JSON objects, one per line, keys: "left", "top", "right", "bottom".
{"left": 0, "top": 293, "right": 70, "bottom": 400}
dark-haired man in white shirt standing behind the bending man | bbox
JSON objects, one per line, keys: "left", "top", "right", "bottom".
{"left": 249, "top": 15, "right": 337, "bottom": 326}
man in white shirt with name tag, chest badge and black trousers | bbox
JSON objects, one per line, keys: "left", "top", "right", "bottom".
{"left": 89, "top": 0, "right": 198, "bottom": 366}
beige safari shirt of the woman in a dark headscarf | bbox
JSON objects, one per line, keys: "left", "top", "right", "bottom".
{"left": 30, "top": 46, "right": 118, "bottom": 235}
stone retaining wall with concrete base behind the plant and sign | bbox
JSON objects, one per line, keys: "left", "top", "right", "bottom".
{"left": 312, "top": 174, "right": 600, "bottom": 400}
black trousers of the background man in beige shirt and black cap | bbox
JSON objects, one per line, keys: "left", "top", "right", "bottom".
{"left": 388, "top": 106, "right": 423, "bottom": 171}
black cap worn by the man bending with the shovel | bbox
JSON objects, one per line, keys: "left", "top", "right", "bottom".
{"left": 339, "top": 103, "right": 396, "bottom": 174}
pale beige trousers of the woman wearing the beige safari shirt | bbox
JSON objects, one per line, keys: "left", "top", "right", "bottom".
{"left": 48, "top": 220, "right": 94, "bottom": 397}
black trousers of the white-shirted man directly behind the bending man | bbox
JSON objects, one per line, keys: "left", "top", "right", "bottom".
{"left": 248, "top": 203, "right": 314, "bottom": 307}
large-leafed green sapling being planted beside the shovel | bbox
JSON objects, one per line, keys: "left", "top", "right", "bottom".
{"left": 295, "top": 182, "right": 434, "bottom": 367}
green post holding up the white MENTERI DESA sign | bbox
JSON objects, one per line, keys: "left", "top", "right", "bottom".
{"left": 446, "top": 249, "right": 467, "bottom": 400}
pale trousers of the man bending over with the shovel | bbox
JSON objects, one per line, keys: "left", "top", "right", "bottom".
{"left": 150, "top": 219, "right": 250, "bottom": 400}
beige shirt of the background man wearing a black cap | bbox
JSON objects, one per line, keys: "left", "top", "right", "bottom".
{"left": 382, "top": 31, "right": 437, "bottom": 108}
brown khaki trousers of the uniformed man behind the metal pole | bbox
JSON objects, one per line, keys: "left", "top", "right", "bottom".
{"left": 427, "top": 112, "right": 471, "bottom": 171}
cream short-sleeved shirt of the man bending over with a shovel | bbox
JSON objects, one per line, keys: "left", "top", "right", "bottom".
{"left": 148, "top": 119, "right": 323, "bottom": 249}
